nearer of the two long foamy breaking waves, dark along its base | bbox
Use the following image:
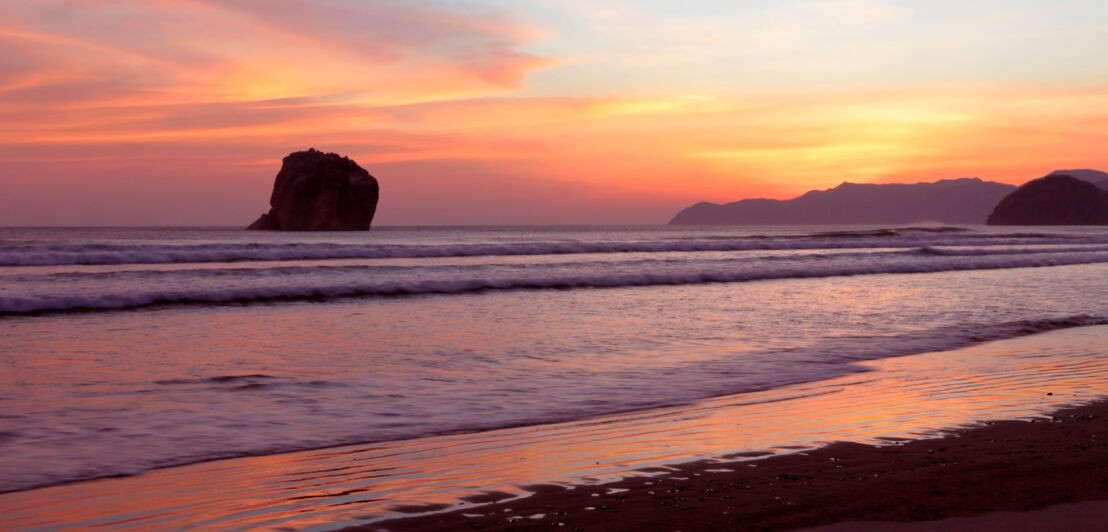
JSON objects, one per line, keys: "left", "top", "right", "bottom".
{"left": 0, "top": 250, "right": 1108, "bottom": 315}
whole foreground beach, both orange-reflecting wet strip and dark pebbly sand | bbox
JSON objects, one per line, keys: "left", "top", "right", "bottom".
{"left": 0, "top": 326, "right": 1108, "bottom": 531}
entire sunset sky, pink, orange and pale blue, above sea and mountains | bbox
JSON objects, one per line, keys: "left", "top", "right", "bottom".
{"left": 0, "top": 0, "right": 1108, "bottom": 226}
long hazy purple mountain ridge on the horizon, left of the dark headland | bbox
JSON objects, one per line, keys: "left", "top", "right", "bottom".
{"left": 669, "top": 177, "right": 1016, "bottom": 225}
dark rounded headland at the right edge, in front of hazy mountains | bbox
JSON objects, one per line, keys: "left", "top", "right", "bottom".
{"left": 988, "top": 174, "right": 1108, "bottom": 225}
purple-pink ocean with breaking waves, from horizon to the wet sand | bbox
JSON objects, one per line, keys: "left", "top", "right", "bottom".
{"left": 0, "top": 226, "right": 1108, "bottom": 491}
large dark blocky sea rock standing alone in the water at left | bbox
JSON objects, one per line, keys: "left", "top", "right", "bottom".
{"left": 247, "top": 149, "right": 379, "bottom": 231}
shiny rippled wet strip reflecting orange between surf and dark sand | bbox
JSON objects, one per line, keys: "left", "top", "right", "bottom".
{"left": 0, "top": 326, "right": 1108, "bottom": 529}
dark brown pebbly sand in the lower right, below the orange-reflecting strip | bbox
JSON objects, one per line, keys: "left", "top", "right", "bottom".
{"left": 363, "top": 401, "right": 1108, "bottom": 531}
